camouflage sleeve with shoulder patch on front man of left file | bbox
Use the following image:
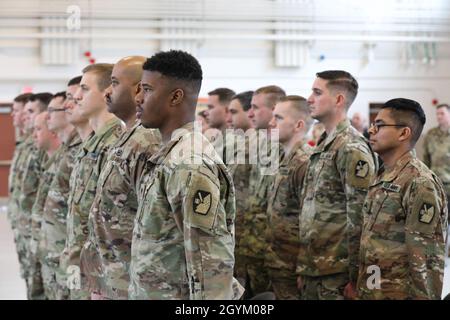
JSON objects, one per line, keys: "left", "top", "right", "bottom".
{"left": 167, "top": 165, "right": 234, "bottom": 300}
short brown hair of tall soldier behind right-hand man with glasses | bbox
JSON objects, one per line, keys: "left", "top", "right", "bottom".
{"left": 316, "top": 70, "right": 359, "bottom": 110}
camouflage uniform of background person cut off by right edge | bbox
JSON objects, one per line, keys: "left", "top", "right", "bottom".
{"left": 423, "top": 128, "right": 450, "bottom": 211}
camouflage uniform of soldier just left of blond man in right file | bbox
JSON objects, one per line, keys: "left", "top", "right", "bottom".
{"left": 239, "top": 132, "right": 280, "bottom": 298}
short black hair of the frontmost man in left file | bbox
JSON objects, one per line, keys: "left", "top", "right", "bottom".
{"left": 142, "top": 50, "right": 203, "bottom": 94}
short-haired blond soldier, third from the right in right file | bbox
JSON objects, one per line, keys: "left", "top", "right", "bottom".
{"left": 264, "top": 96, "right": 313, "bottom": 300}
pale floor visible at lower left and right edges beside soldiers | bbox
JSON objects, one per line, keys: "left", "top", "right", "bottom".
{"left": 0, "top": 198, "right": 450, "bottom": 300}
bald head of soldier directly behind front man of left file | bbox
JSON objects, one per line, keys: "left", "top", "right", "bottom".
{"left": 105, "top": 56, "right": 146, "bottom": 123}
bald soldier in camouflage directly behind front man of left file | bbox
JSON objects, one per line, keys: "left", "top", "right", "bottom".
{"left": 81, "top": 57, "right": 160, "bottom": 300}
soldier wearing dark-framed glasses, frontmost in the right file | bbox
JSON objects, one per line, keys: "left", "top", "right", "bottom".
{"left": 358, "top": 98, "right": 448, "bottom": 300}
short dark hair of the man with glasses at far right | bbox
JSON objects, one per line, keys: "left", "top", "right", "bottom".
{"left": 381, "top": 98, "right": 427, "bottom": 145}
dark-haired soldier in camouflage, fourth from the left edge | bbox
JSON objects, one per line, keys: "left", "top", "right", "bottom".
{"left": 39, "top": 77, "right": 85, "bottom": 300}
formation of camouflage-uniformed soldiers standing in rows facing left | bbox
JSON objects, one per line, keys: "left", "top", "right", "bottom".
{"left": 9, "top": 50, "right": 447, "bottom": 299}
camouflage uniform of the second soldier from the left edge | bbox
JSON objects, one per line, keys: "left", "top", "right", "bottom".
{"left": 18, "top": 136, "right": 48, "bottom": 299}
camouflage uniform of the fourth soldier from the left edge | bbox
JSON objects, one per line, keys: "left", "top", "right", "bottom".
{"left": 39, "top": 130, "right": 82, "bottom": 300}
